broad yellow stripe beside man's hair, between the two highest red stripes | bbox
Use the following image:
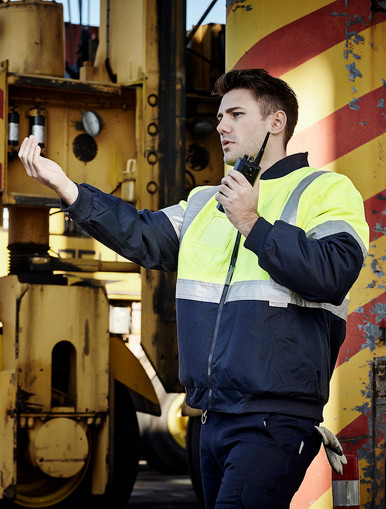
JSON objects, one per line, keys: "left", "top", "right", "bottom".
{"left": 281, "top": 23, "right": 386, "bottom": 133}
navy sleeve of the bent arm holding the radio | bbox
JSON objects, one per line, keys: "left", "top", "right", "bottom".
{"left": 244, "top": 217, "right": 363, "bottom": 305}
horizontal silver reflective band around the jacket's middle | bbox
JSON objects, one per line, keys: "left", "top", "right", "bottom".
{"left": 176, "top": 279, "right": 348, "bottom": 320}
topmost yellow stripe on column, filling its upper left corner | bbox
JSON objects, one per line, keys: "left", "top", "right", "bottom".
{"left": 225, "top": 0, "right": 332, "bottom": 69}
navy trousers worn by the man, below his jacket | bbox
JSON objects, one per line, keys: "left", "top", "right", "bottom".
{"left": 200, "top": 412, "right": 321, "bottom": 509}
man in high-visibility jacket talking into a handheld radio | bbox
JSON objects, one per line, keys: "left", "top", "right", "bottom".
{"left": 20, "top": 69, "right": 368, "bottom": 509}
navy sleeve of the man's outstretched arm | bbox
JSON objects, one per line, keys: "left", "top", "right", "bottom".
{"left": 62, "top": 184, "right": 179, "bottom": 272}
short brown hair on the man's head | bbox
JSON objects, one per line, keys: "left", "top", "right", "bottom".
{"left": 212, "top": 69, "right": 299, "bottom": 146}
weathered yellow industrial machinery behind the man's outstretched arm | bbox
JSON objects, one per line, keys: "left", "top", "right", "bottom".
{"left": 0, "top": 0, "right": 224, "bottom": 508}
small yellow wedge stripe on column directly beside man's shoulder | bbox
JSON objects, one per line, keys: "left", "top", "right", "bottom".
{"left": 321, "top": 133, "right": 386, "bottom": 200}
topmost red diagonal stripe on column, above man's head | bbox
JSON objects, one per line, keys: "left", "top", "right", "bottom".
{"left": 228, "top": 0, "right": 384, "bottom": 76}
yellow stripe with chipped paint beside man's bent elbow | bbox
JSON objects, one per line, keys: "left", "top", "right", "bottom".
{"left": 348, "top": 235, "right": 386, "bottom": 313}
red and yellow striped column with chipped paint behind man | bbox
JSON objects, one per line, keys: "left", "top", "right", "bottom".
{"left": 226, "top": 0, "right": 386, "bottom": 509}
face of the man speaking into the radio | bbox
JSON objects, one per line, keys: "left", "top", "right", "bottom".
{"left": 217, "top": 88, "right": 269, "bottom": 165}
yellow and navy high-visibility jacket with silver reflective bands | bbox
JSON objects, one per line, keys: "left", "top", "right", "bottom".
{"left": 67, "top": 154, "right": 368, "bottom": 422}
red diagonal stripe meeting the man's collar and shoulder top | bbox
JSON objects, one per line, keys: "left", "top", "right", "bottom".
{"left": 289, "top": 86, "right": 386, "bottom": 168}
